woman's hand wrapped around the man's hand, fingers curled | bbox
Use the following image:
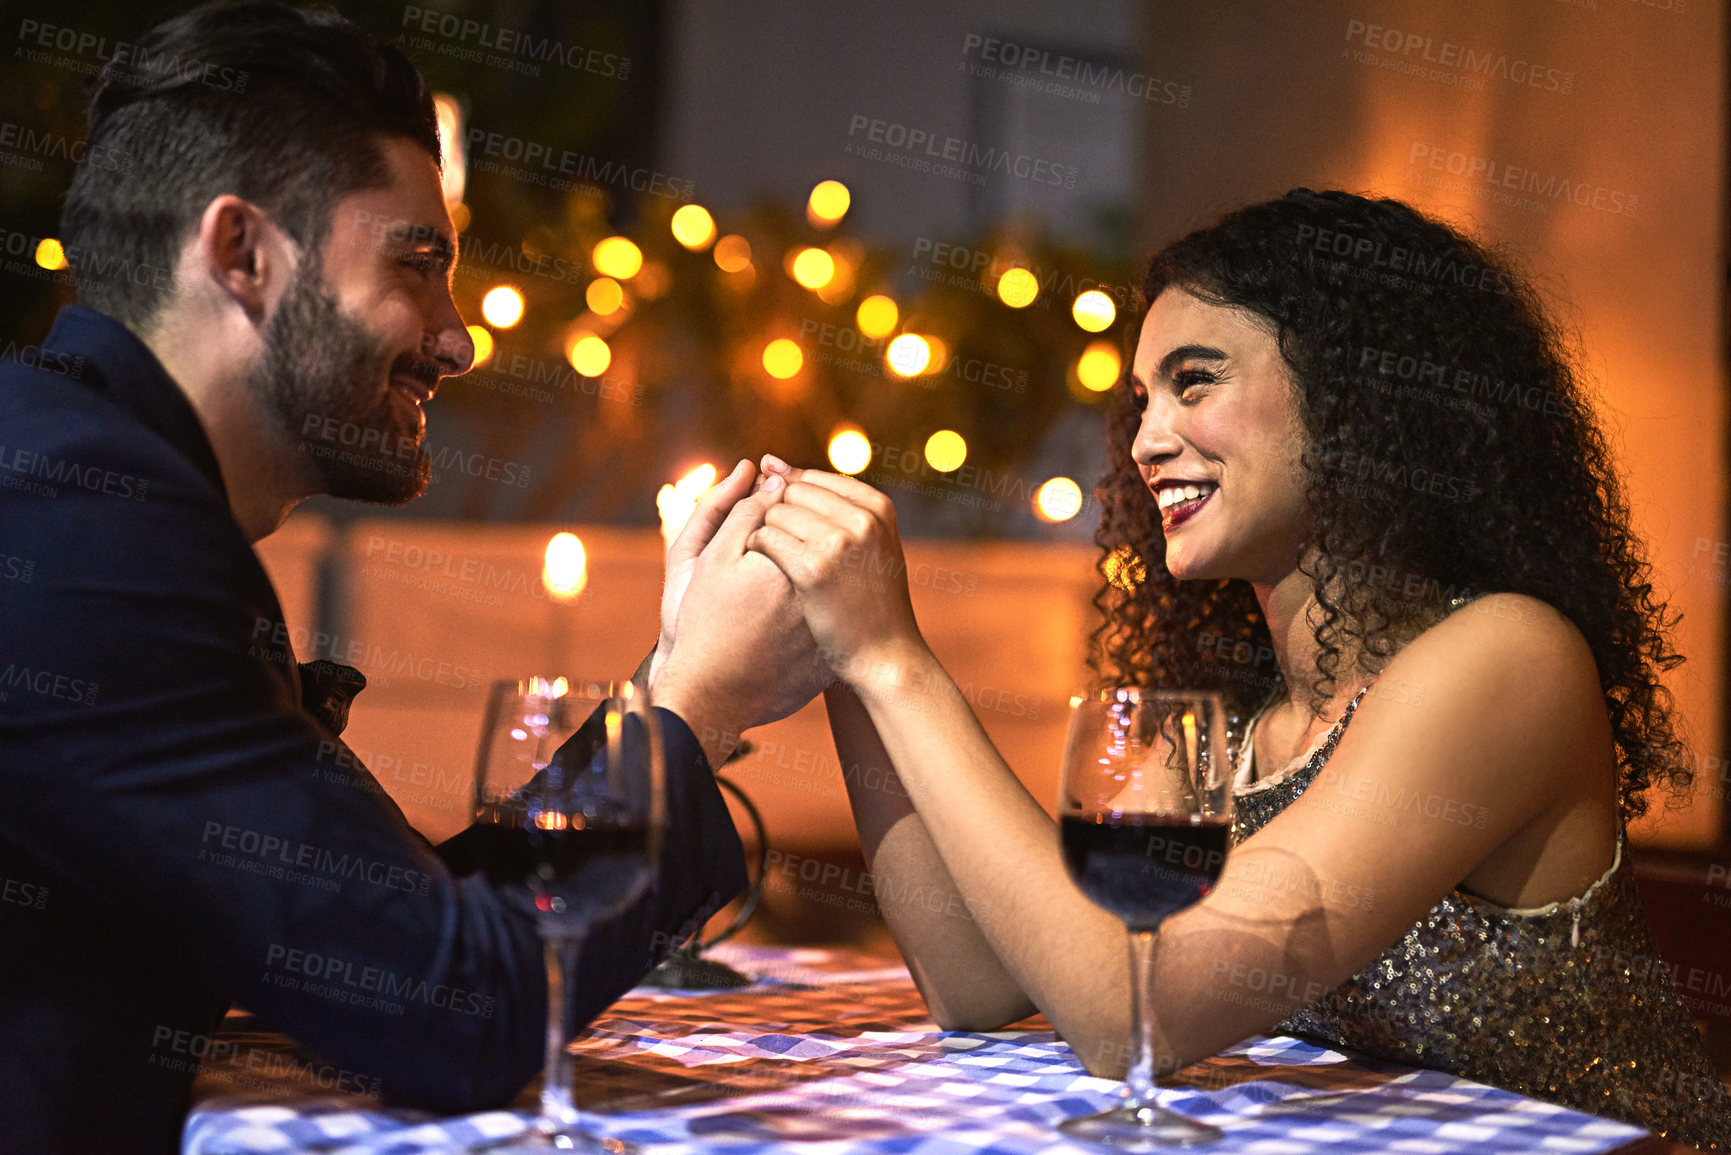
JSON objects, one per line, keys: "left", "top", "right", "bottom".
{"left": 746, "top": 457, "right": 926, "bottom": 694}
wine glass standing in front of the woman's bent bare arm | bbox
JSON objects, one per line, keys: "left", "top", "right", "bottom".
{"left": 1058, "top": 687, "right": 1232, "bottom": 1152}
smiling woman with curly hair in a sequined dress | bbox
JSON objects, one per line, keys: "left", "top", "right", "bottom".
{"left": 750, "top": 189, "right": 1731, "bottom": 1146}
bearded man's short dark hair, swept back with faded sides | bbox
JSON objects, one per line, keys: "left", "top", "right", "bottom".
{"left": 61, "top": 2, "right": 440, "bottom": 329}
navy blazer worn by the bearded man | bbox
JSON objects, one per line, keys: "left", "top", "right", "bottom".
{"left": 0, "top": 306, "right": 746, "bottom": 1155}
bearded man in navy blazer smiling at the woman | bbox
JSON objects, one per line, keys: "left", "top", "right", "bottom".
{"left": 0, "top": 3, "right": 824, "bottom": 1153}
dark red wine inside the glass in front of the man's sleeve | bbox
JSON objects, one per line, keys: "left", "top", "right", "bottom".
{"left": 474, "top": 805, "right": 654, "bottom": 925}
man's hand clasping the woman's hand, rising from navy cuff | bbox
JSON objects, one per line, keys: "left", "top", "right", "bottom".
{"left": 653, "top": 462, "right": 833, "bottom": 767}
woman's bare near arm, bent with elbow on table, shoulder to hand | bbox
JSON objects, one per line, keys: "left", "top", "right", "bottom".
{"left": 753, "top": 473, "right": 1615, "bottom": 1074}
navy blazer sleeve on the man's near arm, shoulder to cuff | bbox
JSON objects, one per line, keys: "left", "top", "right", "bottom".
{"left": 0, "top": 443, "right": 746, "bottom": 1112}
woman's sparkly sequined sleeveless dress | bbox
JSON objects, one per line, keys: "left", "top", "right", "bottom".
{"left": 1232, "top": 687, "right": 1731, "bottom": 1150}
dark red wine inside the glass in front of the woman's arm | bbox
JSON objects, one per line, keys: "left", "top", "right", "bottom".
{"left": 1061, "top": 814, "right": 1231, "bottom": 930}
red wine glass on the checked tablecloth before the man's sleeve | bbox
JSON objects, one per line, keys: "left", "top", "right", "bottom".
{"left": 474, "top": 677, "right": 666, "bottom": 1153}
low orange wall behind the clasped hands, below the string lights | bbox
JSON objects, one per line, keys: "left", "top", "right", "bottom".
{"left": 260, "top": 518, "right": 1094, "bottom": 854}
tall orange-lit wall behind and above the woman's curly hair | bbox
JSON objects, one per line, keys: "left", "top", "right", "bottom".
{"left": 1141, "top": 0, "right": 1731, "bottom": 845}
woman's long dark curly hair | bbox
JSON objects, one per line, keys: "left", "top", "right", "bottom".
{"left": 1092, "top": 189, "right": 1691, "bottom": 819}
